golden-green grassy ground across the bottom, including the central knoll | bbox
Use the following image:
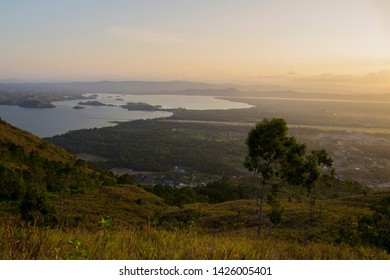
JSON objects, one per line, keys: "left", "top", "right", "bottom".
{"left": 0, "top": 186, "right": 390, "bottom": 259}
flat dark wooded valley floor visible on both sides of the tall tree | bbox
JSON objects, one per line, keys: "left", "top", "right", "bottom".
{"left": 48, "top": 117, "right": 390, "bottom": 187}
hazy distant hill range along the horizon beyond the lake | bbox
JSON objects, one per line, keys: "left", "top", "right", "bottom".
{"left": 0, "top": 81, "right": 390, "bottom": 101}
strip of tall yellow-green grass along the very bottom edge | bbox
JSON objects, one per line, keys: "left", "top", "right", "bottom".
{"left": 0, "top": 224, "right": 390, "bottom": 260}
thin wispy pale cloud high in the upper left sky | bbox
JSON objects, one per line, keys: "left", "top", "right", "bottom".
{"left": 106, "top": 26, "right": 185, "bottom": 43}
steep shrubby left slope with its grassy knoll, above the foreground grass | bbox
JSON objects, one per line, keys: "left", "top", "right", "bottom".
{"left": 0, "top": 120, "right": 171, "bottom": 229}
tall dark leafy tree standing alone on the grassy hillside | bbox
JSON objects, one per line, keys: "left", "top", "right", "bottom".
{"left": 244, "top": 118, "right": 333, "bottom": 238}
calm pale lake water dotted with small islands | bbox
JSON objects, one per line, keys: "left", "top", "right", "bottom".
{"left": 0, "top": 94, "right": 251, "bottom": 137}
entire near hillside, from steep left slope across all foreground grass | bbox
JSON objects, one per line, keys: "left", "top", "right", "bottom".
{"left": 0, "top": 118, "right": 390, "bottom": 259}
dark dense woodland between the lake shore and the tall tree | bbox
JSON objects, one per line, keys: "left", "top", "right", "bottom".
{"left": 48, "top": 120, "right": 247, "bottom": 175}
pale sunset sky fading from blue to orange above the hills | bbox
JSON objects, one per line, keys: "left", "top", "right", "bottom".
{"left": 0, "top": 0, "right": 390, "bottom": 93}
